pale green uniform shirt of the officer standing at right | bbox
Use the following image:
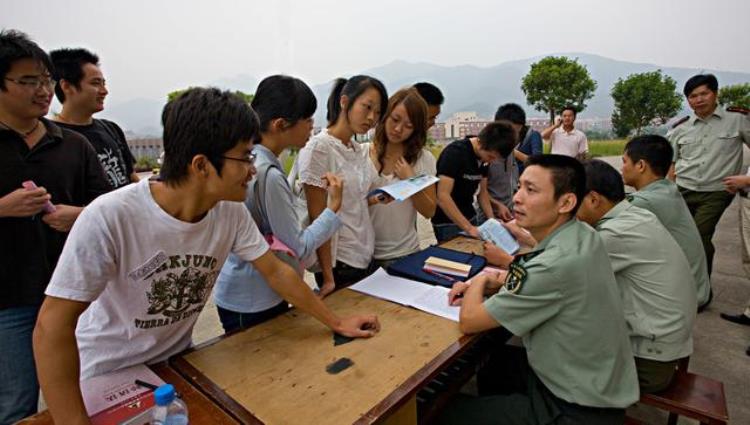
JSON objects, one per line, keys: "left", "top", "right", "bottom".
{"left": 667, "top": 106, "right": 750, "bottom": 192}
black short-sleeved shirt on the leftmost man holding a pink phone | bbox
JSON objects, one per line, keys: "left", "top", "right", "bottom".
{"left": 0, "top": 119, "right": 112, "bottom": 310}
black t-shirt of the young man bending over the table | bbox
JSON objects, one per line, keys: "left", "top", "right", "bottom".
{"left": 432, "top": 137, "right": 488, "bottom": 224}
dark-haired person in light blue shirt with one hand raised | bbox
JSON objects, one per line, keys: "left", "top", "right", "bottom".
{"left": 214, "top": 75, "right": 343, "bottom": 332}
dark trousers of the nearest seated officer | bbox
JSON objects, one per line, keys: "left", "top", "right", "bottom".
{"left": 437, "top": 346, "right": 625, "bottom": 425}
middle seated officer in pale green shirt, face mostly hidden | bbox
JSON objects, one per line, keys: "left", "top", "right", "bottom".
{"left": 578, "top": 160, "right": 696, "bottom": 393}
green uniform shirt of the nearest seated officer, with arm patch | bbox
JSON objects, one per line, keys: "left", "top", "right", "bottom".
{"left": 484, "top": 219, "right": 639, "bottom": 408}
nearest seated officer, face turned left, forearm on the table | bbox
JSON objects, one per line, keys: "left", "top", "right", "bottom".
{"left": 440, "top": 155, "right": 639, "bottom": 424}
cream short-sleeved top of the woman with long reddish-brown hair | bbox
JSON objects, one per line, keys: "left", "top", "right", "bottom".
{"left": 366, "top": 144, "right": 437, "bottom": 260}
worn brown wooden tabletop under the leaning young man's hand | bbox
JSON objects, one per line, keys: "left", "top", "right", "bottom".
{"left": 181, "top": 289, "right": 468, "bottom": 424}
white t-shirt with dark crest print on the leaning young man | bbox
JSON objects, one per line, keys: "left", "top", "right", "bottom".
{"left": 46, "top": 179, "right": 268, "bottom": 379}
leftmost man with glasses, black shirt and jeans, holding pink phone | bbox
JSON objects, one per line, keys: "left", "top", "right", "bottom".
{"left": 0, "top": 31, "right": 110, "bottom": 424}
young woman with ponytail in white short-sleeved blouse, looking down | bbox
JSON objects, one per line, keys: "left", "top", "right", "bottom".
{"left": 290, "top": 75, "right": 388, "bottom": 295}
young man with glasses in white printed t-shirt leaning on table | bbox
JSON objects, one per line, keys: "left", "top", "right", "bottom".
{"left": 34, "top": 88, "right": 379, "bottom": 424}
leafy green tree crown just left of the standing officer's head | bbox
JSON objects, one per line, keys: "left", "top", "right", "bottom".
{"left": 611, "top": 70, "right": 682, "bottom": 137}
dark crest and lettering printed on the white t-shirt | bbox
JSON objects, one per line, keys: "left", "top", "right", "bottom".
{"left": 134, "top": 254, "right": 219, "bottom": 329}
